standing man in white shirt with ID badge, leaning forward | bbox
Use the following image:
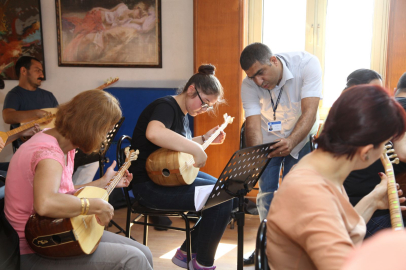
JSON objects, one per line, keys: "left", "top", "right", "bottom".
{"left": 240, "top": 43, "right": 322, "bottom": 264}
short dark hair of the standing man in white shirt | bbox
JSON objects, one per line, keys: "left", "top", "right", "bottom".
{"left": 240, "top": 42, "right": 272, "bottom": 70}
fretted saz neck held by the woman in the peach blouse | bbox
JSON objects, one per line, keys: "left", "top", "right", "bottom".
{"left": 381, "top": 145, "right": 404, "bottom": 231}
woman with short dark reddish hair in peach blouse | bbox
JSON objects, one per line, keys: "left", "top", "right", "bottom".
{"left": 267, "top": 85, "right": 406, "bottom": 270}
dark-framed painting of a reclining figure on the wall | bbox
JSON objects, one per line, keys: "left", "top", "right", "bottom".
{"left": 55, "top": 0, "right": 162, "bottom": 68}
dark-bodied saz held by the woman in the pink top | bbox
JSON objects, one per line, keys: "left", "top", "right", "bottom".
{"left": 25, "top": 147, "right": 139, "bottom": 257}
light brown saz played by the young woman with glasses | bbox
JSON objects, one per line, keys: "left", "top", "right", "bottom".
{"left": 145, "top": 114, "right": 234, "bottom": 187}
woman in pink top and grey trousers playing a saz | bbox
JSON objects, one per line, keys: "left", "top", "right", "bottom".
{"left": 4, "top": 90, "right": 152, "bottom": 269}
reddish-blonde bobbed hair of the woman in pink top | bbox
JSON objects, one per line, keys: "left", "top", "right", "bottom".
{"left": 55, "top": 90, "right": 121, "bottom": 154}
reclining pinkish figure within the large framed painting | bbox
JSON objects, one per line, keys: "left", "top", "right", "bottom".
{"left": 62, "top": 2, "right": 156, "bottom": 62}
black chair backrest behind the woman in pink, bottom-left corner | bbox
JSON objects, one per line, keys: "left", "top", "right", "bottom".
{"left": 0, "top": 199, "right": 20, "bottom": 269}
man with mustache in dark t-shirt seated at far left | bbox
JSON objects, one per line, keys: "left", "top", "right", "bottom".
{"left": 3, "top": 56, "right": 58, "bottom": 147}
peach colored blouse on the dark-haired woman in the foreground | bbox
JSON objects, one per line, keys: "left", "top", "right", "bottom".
{"left": 266, "top": 168, "right": 366, "bottom": 270}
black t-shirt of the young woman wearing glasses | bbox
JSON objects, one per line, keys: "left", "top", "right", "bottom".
{"left": 129, "top": 96, "right": 192, "bottom": 183}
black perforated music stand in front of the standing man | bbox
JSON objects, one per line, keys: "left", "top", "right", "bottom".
{"left": 202, "top": 142, "right": 276, "bottom": 270}
